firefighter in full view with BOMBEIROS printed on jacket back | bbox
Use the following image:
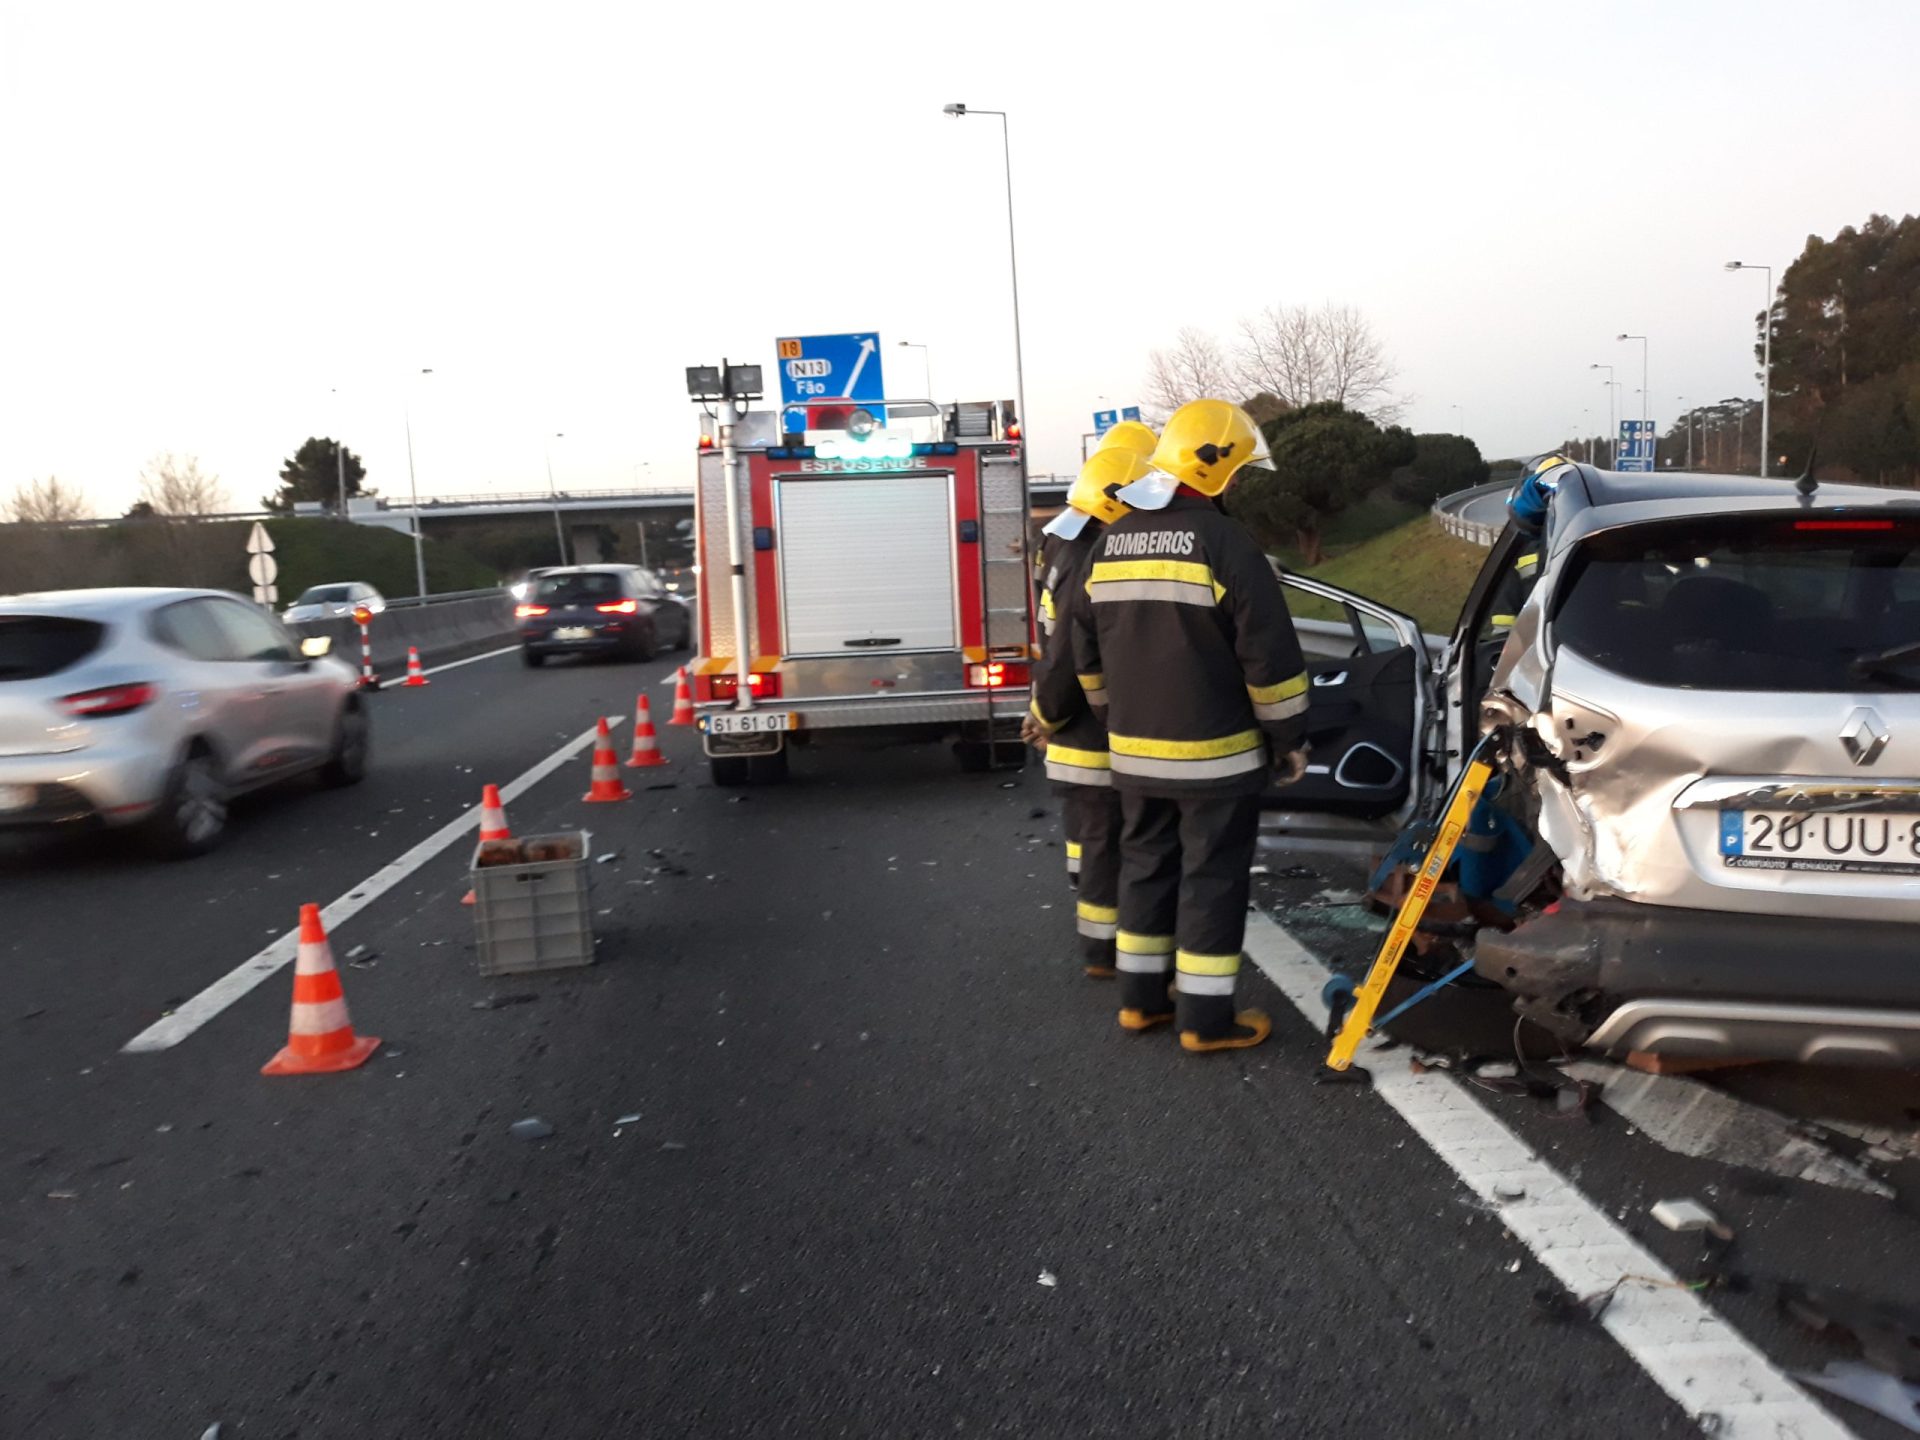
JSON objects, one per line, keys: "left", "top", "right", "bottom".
{"left": 1071, "top": 399, "right": 1308, "bottom": 1054}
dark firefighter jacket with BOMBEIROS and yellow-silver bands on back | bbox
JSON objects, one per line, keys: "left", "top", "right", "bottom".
{"left": 1035, "top": 492, "right": 1308, "bottom": 795}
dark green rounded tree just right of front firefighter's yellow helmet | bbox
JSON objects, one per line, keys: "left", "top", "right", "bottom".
{"left": 1227, "top": 399, "right": 1417, "bottom": 566}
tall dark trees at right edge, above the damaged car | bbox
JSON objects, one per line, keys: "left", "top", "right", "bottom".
{"left": 1755, "top": 215, "right": 1920, "bottom": 486}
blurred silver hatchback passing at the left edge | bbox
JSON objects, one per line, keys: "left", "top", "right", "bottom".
{"left": 0, "top": 589, "right": 369, "bottom": 856}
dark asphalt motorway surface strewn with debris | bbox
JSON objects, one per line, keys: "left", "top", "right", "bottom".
{"left": 0, "top": 657, "right": 1916, "bottom": 1440}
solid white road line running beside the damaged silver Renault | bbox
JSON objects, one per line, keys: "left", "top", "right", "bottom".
{"left": 1246, "top": 914, "right": 1853, "bottom": 1440}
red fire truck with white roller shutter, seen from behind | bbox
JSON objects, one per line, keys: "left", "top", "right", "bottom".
{"left": 691, "top": 401, "right": 1039, "bottom": 785}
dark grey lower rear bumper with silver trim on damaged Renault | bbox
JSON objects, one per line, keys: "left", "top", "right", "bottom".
{"left": 1475, "top": 899, "right": 1920, "bottom": 1066}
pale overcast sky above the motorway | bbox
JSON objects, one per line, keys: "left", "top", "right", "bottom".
{"left": 0, "top": 0, "right": 1920, "bottom": 511}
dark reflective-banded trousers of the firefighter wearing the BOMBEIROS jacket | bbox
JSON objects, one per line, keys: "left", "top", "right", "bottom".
{"left": 1116, "top": 791, "right": 1260, "bottom": 1037}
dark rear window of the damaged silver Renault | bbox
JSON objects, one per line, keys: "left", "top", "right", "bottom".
{"left": 1553, "top": 513, "right": 1920, "bottom": 691}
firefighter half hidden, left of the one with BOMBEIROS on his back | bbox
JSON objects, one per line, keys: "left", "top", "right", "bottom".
{"left": 1020, "top": 443, "right": 1152, "bottom": 979}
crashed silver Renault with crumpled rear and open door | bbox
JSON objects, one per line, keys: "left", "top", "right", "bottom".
{"left": 1269, "top": 465, "right": 1920, "bottom": 1066}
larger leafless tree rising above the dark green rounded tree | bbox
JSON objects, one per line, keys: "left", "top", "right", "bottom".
{"left": 1233, "top": 301, "right": 1405, "bottom": 424}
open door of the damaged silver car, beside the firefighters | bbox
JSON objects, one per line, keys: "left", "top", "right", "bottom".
{"left": 1261, "top": 572, "right": 1434, "bottom": 852}
